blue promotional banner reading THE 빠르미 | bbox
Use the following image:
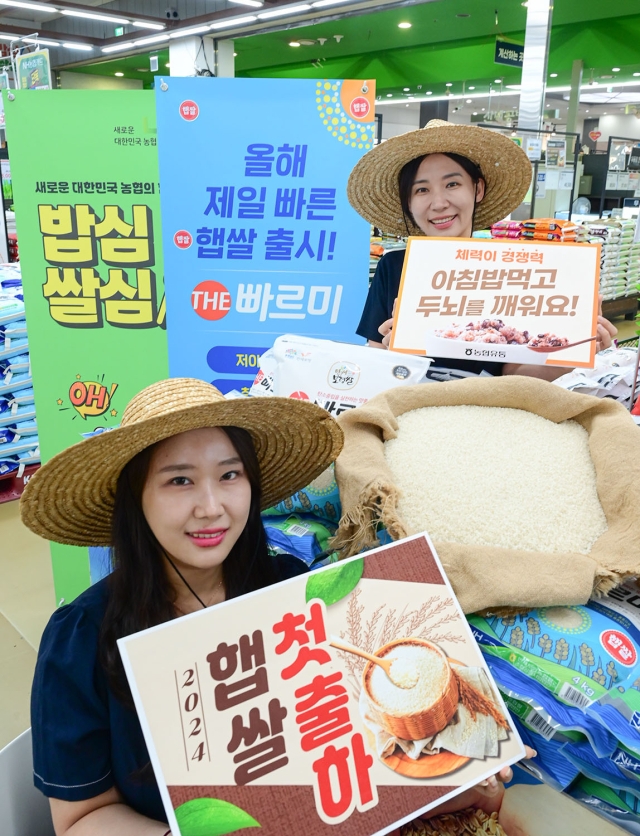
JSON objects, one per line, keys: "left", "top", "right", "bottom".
{"left": 156, "top": 78, "right": 375, "bottom": 392}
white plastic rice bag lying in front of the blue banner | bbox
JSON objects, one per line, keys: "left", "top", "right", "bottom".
{"left": 250, "top": 334, "right": 431, "bottom": 416}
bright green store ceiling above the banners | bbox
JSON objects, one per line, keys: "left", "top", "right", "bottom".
{"left": 67, "top": 0, "right": 640, "bottom": 104}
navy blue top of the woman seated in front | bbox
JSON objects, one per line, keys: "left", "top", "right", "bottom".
{"left": 31, "top": 555, "right": 307, "bottom": 822}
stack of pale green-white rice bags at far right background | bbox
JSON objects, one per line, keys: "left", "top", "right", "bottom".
{"left": 576, "top": 218, "right": 640, "bottom": 300}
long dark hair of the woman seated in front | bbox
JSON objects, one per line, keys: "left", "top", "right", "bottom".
{"left": 99, "top": 427, "right": 277, "bottom": 705}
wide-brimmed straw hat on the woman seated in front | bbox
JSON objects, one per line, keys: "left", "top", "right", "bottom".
{"left": 20, "top": 378, "right": 343, "bottom": 546}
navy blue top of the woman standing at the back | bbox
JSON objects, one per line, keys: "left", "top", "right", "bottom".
{"left": 356, "top": 250, "right": 504, "bottom": 379}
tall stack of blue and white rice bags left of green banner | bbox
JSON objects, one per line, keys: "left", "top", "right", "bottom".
{"left": 0, "top": 263, "right": 40, "bottom": 476}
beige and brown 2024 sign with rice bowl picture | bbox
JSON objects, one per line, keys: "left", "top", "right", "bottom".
{"left": 119, "top": 535, "right": 524, "bottom": 836}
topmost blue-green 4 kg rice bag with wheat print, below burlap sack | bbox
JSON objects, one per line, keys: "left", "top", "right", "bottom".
{"left": 469, "top": 581, "right": 640, "bottom": 756}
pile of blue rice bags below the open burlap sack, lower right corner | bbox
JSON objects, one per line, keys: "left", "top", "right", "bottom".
{"left": 469, "top": 582, "right": 640, "bottom": 834}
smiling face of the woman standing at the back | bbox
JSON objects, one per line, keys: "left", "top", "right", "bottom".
{"left": 409, "top": 154, "right": 484, "bottom": 238}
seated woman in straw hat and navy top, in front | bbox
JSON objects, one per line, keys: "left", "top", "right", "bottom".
{"left": 21, "top": 379, "right": 342, "bottom": 836}
